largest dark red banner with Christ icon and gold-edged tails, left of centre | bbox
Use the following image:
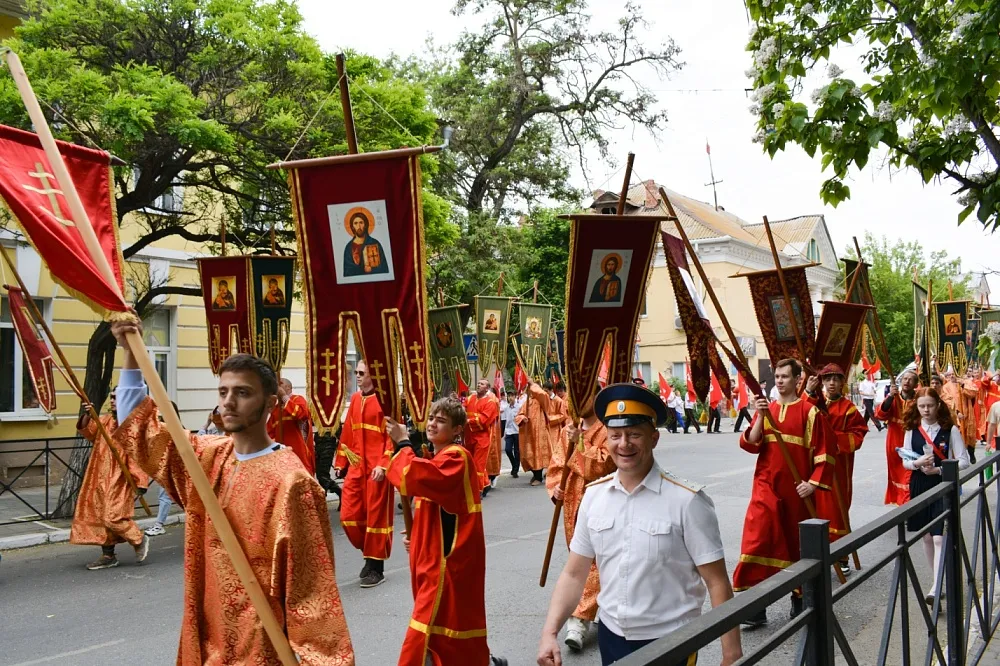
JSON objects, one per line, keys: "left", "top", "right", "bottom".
{"left": 284, "top": 151, "right": 431, "bottom": 428}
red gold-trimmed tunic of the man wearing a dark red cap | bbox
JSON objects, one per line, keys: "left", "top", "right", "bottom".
{"left": 809, "top": 396, "right": 868, "bottom": 541}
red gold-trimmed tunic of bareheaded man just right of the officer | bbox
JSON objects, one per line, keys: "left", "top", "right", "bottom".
{"left": 733, "top": 400, "right": 837, "bottom": 591}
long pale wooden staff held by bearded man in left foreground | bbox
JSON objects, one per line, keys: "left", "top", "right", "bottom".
{"left": 3, "top": 49, "right": 298, "bottom": 666}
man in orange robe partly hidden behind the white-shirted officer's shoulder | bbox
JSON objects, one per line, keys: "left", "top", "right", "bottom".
{"left": 545, "top": 396, "right": 617, "bottom": 650}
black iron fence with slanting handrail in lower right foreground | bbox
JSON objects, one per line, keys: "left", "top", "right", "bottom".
{"left": 617, "top": 456, "right": 1000, "bottom": 666}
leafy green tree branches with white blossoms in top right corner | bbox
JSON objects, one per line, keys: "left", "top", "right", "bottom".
{"left": 746, "top": 0, "right": 1000, "bottom": 229}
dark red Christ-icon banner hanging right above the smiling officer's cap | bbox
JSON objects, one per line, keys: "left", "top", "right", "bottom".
{"left": 564, "top": 215, "right": 664, "bottom": 406}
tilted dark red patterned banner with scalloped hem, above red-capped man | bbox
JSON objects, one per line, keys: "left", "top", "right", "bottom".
{"left": 735, "top": 266, "right": 816, "bottom": 364}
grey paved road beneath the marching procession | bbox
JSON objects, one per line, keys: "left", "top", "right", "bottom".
{"left": 0, "top": 422, "right": 968, "bottom": 666}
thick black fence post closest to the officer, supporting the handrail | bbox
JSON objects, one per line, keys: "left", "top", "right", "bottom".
{"left": 799, "top": 518, "right": 835, "bottom": 666}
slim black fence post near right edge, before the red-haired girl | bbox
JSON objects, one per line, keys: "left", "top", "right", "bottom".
{"left": 941, "top": 460, "right": 965, "bottom": 666}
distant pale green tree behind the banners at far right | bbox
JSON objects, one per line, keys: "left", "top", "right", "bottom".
{"left": 845, "top": 233, "right": 969, "bottom": 371}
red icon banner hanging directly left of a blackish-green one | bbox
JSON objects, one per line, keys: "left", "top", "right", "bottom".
{"left": 198, "top": 257, "right": 254, "bottom": 374}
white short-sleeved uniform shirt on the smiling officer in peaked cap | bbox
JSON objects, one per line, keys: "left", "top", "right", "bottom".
{"left": 569, "top": 463, "right": 725, "bottom": 640}
